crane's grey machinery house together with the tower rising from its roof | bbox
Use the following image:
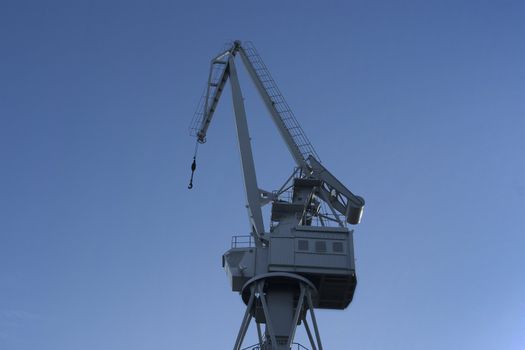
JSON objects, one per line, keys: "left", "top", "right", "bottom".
{"left": 223, "top": 178, "right": 357, "bottom": 309}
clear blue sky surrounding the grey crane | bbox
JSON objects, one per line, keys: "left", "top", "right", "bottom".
{"left": 0, "top": 0, "right": 525, "bottom": 350}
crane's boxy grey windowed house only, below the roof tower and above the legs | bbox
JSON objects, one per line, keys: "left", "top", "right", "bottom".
{"left": 222, "top": 226, "right": 357, "bottom": 309}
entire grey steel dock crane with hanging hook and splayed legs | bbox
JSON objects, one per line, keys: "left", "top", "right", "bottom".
{"left": 188, "top": 41, "right": 365, "bottom": 350}
